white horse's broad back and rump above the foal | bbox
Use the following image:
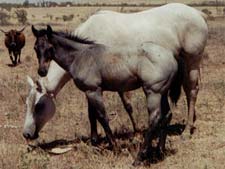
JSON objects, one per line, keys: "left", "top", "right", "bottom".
{"left": 75, "top": 3, "right": 207, "bottom": 54}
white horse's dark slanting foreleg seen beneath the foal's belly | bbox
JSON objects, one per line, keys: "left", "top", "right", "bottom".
{"left": 119, "top": 92, "right": 137, "bottom": 132}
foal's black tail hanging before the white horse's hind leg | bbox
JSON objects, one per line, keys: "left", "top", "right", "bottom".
{"left": 169, "top": 57, "right": 184, "bottom": 105}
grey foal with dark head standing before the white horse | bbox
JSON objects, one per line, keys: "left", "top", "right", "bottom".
{"left": 32, "top": 26, "right": 181, "bottom": 163}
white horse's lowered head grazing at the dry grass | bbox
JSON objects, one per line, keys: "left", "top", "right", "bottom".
{"left": 23, "top": 76, "right": 55, "bottom": 140}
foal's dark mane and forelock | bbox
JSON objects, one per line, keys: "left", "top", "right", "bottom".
{"left": 39, "top": 29, "right": 95, "bottom": 44}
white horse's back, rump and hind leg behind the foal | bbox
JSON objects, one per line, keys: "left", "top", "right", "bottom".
{"left": 74, "top": 3, "right": 208, "bottom": 137}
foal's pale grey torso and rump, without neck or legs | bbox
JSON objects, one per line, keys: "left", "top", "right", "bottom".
{"left": 81, "top": 42, "right": 177, "bottom": 91}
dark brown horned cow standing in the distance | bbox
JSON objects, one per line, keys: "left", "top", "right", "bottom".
{"left": 0, "top": 27, "right": 25, "bottom": 65}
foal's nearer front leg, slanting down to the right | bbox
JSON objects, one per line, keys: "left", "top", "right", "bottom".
{"left": 86, "top": 88, "right": 115, "bottom": 148}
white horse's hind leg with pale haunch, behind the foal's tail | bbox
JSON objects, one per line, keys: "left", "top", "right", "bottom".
{"left": 181, "top": 19, "right": 208, "bottom": 137}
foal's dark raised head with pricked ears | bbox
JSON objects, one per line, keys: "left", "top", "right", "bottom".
{"left": 32, "top": 25, "right": 54, "bottom": 77}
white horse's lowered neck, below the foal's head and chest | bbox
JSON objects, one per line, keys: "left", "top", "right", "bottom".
{"left": 39, "top": 61, "right": 71, "bottom": 96}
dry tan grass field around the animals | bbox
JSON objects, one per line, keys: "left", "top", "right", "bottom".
{"left": 0, "top": 3, "right": 225, "bottom": 169}
